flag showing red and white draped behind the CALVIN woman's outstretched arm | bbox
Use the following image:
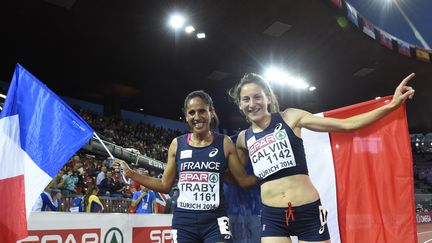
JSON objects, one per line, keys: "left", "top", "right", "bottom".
{"left": 302, "top": 96, "right": 417, "bottom": 243}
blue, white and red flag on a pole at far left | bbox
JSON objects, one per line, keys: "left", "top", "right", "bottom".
{"left": 0, "top": 64, "right": 93, "bottom": 242}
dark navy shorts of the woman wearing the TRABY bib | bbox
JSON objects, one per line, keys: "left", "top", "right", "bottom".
{"left": 172, "top": 212, "right": 232, "bottom": 243}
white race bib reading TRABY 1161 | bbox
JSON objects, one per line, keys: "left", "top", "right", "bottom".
{"left": 177, "top": 171, "right": 220, "bottom": 210}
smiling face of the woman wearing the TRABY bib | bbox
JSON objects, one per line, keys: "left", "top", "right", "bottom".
{"left": 185, "top": 97, "right": 212, "bottom": 133}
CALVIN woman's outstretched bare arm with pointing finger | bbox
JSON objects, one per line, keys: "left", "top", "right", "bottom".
{"left": 296, "top": 73, "right": 414, "bottom": 132}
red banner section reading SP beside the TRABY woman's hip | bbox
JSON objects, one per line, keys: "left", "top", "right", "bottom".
{"left": 132, "top": 226, "right": 176, "bottom": 243}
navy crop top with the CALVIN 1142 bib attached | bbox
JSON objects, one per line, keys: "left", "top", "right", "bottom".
{"left": 245, "top": 113, "right": 308, "bottom": 183}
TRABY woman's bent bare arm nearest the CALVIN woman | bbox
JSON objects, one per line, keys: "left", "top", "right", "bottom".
{"left": 224, "top": 136, "right": 257, "bottom": 188}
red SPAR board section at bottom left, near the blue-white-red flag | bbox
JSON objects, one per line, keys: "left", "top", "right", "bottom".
{"left": 17, "top": 229, "right": 100, "bottom": 243}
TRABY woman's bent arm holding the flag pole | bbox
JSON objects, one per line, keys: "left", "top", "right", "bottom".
{"left": 114, "top": 139, "right": 177, "bottom": 193}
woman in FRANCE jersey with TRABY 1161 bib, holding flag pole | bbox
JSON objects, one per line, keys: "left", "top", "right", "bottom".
{"left": 115, "top": 91, "right": 256, "bottom": 243}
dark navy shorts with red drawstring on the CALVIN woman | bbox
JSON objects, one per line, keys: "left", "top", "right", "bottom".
{"left": 261, "top": 200, "right": 330, "bottom": 241}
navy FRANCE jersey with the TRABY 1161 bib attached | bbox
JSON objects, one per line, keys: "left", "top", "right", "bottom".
{"left": 176, "top": 133, "right": 227, "bottom": 212}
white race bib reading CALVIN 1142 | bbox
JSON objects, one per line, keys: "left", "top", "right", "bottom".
{"left": 248, "top": 129, "right": 296, "bottom": 179}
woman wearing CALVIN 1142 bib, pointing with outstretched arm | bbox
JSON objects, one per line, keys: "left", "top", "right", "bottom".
{"left": 229, "top": 73, "right": 414, "bottom": 243}
